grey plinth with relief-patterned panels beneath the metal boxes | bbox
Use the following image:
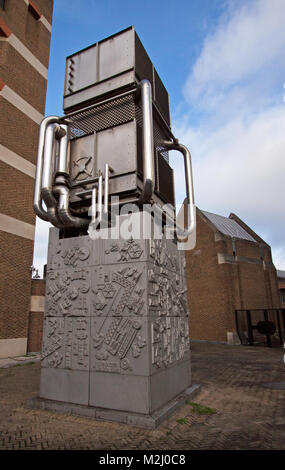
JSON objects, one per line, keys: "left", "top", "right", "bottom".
{"left": 32, "top": 215, "right": 196, "bottom": 427}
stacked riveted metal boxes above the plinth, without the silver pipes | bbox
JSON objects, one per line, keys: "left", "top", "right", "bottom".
{"left": 64, "top": 27, "right": 175, "bottom": 207}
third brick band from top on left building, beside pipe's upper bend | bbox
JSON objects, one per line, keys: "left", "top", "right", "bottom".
{"left": 0, "top": 96, "right": 39, "bottom": 164}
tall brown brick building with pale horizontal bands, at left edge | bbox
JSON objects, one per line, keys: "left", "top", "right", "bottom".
{"left": 0, "top": 0, "right": 53, "bottom": 357}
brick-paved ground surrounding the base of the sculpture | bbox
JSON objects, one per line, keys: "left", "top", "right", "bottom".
{"left": 0, "top": 343, "right": 285, "bottom": 450}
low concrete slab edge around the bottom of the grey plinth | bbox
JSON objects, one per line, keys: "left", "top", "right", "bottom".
{"left": 27, "top": 384, "right": 201, "bottom": 429}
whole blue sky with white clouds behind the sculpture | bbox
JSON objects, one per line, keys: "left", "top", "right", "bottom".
{"left": 34, "top": 0, "right": 285, "bottom": 274}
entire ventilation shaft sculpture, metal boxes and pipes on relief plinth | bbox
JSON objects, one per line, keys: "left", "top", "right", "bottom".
{"left": 34, "top": 27, "right": 196, "bottom": 426}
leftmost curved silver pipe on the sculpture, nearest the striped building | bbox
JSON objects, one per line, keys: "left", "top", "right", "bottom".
{"left": 33, "top": 116, "right": 60, "bottom": 222}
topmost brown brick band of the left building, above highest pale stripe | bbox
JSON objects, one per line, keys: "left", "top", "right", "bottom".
{"left": 0, "top": 0, "right": 52, "bottom": 67}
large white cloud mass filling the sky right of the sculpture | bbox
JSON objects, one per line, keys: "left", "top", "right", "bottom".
{"left": 175, "top": 0, "right": 285, "bottom": 269}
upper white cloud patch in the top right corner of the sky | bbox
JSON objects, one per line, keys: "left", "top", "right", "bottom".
{"left": 185, "top": 0, "right": 285, "bottom": 106}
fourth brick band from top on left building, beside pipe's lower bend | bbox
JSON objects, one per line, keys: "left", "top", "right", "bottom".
{"left": 0, "top": 161, "right": 36, "bottom": 225}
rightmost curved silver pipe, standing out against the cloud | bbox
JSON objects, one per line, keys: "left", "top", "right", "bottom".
{"left": 163, "top": 141, "right": 196, "bottom": 241}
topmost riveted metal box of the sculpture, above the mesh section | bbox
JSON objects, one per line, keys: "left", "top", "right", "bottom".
{"left": 63, "top": 27, "right": 170, "bottom": 125}
